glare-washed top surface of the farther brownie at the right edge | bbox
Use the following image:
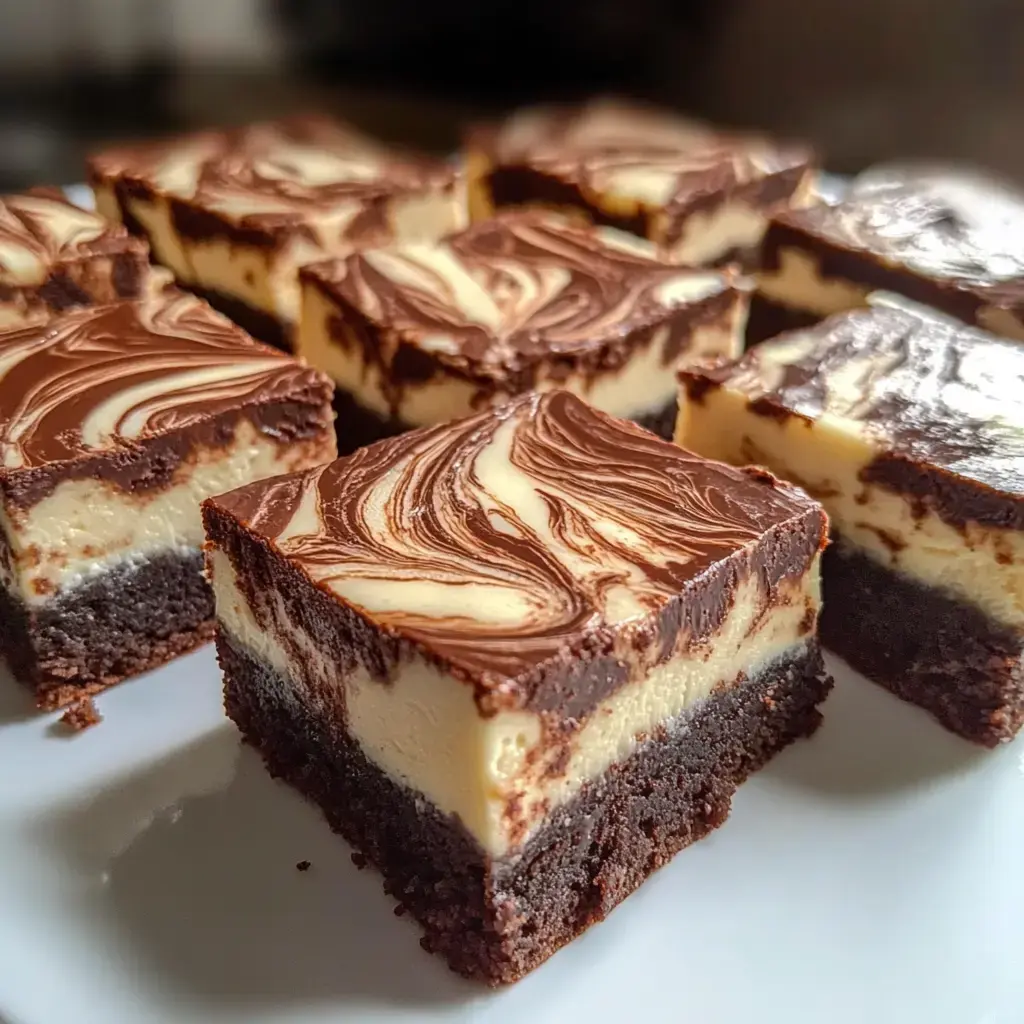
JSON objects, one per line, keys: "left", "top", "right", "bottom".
{"left": 777, "top": 169, "right": 1024, "bottom": 304}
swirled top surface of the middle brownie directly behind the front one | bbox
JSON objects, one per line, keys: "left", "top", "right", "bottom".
{"left": 304, "top": 213, "right": 736, "bottom": 377}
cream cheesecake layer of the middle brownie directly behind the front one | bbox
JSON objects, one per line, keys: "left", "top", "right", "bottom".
{"left": 297, "top": 260, "right": 748, "bottom": 427}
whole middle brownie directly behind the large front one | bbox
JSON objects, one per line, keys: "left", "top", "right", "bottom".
{"left": 298, "top": 213, "right": 748, "bottom": 451}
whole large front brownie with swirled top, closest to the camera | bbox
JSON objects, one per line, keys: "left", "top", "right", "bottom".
{"left": 204, "top": 391, "right": 830, "bottom": 984}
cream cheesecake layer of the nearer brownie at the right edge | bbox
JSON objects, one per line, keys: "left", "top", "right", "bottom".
{"left": 676, "top": 382, "right": 1024, "bottom": 629}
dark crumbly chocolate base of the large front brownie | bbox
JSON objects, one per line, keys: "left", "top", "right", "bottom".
{"left": 217, "top": 634, "right": 831, "bottom": 985}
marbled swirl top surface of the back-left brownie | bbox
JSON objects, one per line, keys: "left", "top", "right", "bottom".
{"left": 89, "top": 118, "right": 456, "bottom": 230}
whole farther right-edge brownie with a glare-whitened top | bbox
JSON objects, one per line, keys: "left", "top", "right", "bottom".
{"left": 748, "top": 169, "right": 1024, "bottom": 343}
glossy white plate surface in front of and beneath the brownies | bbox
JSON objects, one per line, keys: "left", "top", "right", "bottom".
{"left": 0, "top": 649, "right": 1024, "bottom": 1024}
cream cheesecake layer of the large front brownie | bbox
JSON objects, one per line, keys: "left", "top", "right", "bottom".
{"left": 208, "top": 549, "right": 820, "bottom": 857}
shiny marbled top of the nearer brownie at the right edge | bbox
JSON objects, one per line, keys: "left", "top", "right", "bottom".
{"left": 681, "top": 307, "right": 1024, "bottom": 496}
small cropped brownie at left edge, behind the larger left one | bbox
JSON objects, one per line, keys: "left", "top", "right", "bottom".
{"left": 0, "top": 188, "right": 150, "bottom": 330}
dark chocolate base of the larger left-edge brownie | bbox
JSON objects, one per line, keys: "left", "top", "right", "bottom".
{"left": 0, "top": 552, "right": 213, "bottom": 710}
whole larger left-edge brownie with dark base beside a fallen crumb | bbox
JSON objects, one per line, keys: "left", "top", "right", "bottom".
{"left": 0, "top": 292, "right": 335, "bottom": 708}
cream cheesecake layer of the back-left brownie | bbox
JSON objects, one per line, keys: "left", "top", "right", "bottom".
{"left": 96, "top": 185, "right": 465, "bottom": 325}
